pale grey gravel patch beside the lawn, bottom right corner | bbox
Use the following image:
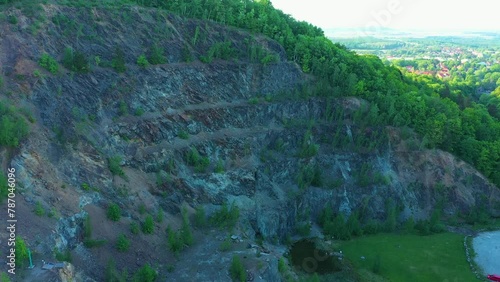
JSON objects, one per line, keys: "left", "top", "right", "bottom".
{"left": 472, "top": 231, "right": 500, "bottom": 275}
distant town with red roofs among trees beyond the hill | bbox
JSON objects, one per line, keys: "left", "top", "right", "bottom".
{"left": 330, "top": 31, "right": 500, "bottom": 98}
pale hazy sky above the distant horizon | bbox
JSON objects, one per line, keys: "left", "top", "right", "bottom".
{"left": 271, "top": 0, "right": 500, "bottom": 32}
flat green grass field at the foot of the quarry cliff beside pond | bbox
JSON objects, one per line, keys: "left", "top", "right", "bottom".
{"left": 340, "top": 233, "right": 477, "bottom": 282}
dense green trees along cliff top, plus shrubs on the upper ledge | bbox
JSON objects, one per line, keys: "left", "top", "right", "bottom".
{"left": 3, "top": 0, "right": 500, "bottom": 186}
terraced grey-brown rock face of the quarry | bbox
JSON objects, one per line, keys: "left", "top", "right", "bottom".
{"left": 0, "top": 5, "right": 500, "bottom": 281}
